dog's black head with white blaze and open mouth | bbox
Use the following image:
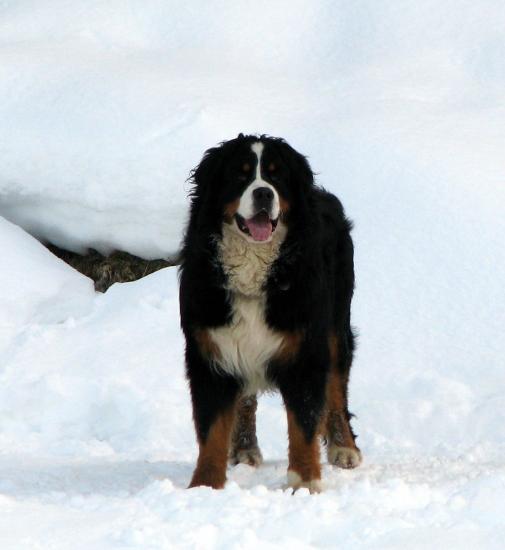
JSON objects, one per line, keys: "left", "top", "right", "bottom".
{"left": 191, "top": 134, "right": 314, "bottom": 243}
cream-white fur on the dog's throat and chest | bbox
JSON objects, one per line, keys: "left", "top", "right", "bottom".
{"left": 209, "top": 223, "right": 285, "bottom": 393}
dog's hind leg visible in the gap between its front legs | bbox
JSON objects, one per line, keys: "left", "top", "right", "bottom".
{"left": 230, "top": 395, "right": 263, "bottom": 466}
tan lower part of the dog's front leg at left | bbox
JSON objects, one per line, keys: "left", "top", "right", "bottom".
{"left": 189, "top": 406, "right": 236, "bottom": 489}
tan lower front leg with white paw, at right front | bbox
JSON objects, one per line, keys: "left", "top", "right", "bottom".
{"left": 287, "top": 409, "right": 321, "bottom": 493}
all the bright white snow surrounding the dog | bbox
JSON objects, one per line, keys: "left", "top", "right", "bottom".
{"left": 0, "top": 0, "right": 505, "bottom": 550}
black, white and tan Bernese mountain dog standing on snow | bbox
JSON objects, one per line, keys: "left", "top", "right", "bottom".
{"left": 180, "top": 134, "right": 361, "bottom": 493}
